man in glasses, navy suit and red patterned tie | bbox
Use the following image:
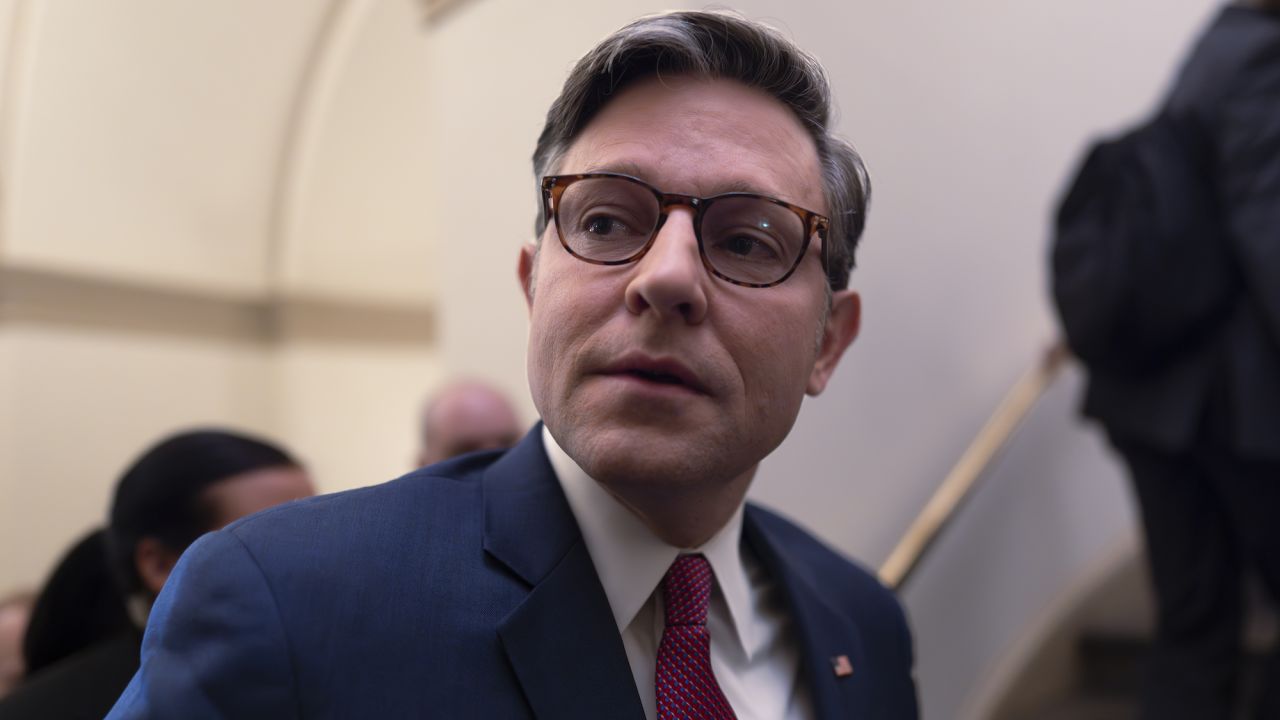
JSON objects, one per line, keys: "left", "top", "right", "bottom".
{"left": 104, "top": 12, "right": 918, "bottom": 720}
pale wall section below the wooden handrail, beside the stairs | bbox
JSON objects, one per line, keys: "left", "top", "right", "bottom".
{"left": 902, "top": 365, "right": 1137, "bottom": 720}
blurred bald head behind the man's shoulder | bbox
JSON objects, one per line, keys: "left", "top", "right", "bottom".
{"left": 417, "top": 380, "right": 524, "bottom": 466}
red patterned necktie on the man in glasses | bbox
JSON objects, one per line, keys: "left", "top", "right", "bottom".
{"left": 654, "top": 555, "right": 735, "bottom": 720}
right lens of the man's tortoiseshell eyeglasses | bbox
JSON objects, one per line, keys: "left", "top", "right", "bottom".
{"left": 703, "top": 197, "right": 805, "bottom": 284}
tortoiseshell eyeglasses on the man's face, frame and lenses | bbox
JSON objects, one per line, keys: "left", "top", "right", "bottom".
{"left": 543, "top": 173, "right": 829, "bottom": 287}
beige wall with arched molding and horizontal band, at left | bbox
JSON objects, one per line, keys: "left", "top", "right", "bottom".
{"left": 0, "top": 0, "right": 447, "bottom": 589}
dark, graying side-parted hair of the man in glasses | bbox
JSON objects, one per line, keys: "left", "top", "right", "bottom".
{"left": 534, "top": 12, "right": 870, "bottom": 290}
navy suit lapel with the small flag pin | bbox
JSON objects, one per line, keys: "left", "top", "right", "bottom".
{"left": 742, "top": 505, "right": 873, "bottom": 720}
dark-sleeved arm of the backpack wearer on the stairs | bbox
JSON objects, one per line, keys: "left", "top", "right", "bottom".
{"left": 1215, "top": 42, "right": 1280, "bottom": 343}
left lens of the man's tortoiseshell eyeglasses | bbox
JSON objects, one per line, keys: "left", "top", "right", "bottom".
{"left": 556, "top": 178, "right": 662, "bottom": 263}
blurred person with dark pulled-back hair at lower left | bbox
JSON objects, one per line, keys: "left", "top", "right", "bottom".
{"left": 0, "top": 429, "right": 315, "bottom": 720}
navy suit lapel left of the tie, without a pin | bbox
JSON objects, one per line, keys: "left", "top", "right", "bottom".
{"left": 483, "top": 424, "right": 644, "bottom": 720}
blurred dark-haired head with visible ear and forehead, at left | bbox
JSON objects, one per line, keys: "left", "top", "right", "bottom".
{"left": 108, "top": 430, "right": 315, "bottom": 601}
